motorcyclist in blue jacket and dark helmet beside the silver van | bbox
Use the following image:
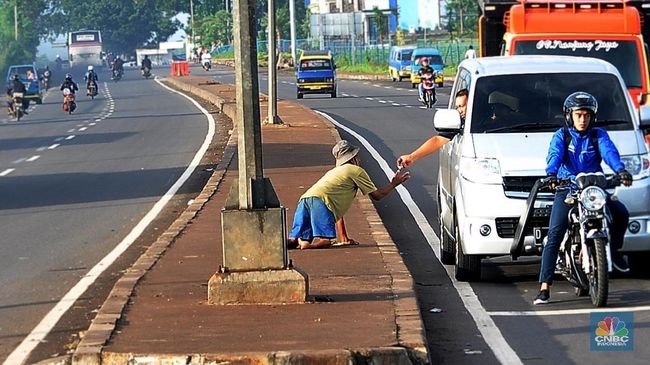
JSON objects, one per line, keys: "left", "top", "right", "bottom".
{"left": 533, "top": 91, "right": 632, "bottom": 304}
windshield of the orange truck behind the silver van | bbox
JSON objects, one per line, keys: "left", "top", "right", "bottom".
{"left": 514, "top": 39, "right": 643, "bottom": 88}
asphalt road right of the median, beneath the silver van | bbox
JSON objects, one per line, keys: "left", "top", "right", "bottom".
{"left": 211, "top": 68, "right": 650, "bottom": 364}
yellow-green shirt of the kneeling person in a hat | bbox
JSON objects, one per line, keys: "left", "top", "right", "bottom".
{"left": 300, "top": 163, "right": 377, "bottom": 220}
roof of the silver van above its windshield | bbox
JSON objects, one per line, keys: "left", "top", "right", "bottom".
{"left": 458, "top": 55, "right": 620, "bottom": 76}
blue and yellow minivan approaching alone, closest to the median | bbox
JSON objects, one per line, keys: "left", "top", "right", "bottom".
{"left": 296, "top": 51, "right": 336, "bottom": 99}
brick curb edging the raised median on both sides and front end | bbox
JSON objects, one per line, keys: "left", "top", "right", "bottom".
{"left": 68, "top": 78, "right": 429, "bottom": 365}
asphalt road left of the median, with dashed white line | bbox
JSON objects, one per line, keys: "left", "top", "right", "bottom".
{"left": 0, "top": 70, "right": 218, "bottom": 361}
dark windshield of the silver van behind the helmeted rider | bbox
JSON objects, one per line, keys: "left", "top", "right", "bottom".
{"left": 470, "top": 73, "right": 634, "bottom": 133}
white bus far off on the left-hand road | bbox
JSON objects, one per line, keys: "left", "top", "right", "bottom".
{"left": 67, "top": 30, "right": 103, "bottom": 67}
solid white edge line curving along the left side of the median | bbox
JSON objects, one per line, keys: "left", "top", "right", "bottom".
{"left": 0, "top": 75, "right": 215, "bottom": 365}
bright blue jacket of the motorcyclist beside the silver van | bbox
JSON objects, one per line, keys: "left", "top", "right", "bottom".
{"left": 546, "top": 128, "right": 625, "bottom": 179}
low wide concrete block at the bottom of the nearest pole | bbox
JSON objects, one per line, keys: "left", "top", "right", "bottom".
{"left": 208, "top": 267, "right": 309, "bottom": 305}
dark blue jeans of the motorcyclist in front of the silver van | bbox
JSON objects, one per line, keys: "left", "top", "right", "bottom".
{"left": 539, "top": 190, "right": 630, "bottom": 285}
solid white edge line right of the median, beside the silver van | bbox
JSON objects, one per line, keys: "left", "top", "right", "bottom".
{"left": 316, "top": 111, "right": 523, "bottom": 365}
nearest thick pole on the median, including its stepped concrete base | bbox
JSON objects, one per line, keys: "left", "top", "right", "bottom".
{"left": 208, "top": 0, "right": 308, "bottom": 305}
